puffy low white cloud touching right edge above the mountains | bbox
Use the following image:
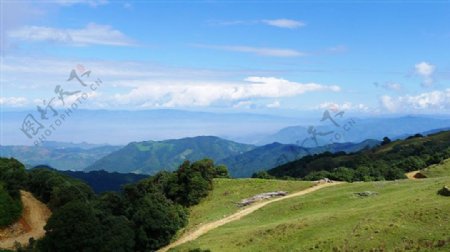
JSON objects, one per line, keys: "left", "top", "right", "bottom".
{"left": 380, "top": 89, "right": 450, "bottom": 112}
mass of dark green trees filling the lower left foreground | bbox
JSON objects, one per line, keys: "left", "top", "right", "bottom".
{"left": 0, "top": 158, "right": 229, "bottom": 252}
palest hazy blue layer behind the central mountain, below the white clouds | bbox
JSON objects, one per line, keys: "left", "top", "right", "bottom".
{"left": 0, "top": 109, "right": 300, "bottom": 145}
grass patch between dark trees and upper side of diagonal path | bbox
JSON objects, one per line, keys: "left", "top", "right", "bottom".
{"left": 179, "top": 179, "right": 313, "bottom": 236}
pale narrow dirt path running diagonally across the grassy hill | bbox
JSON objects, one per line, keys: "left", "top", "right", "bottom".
{"left": 159, "top": 182, "right": 342, "bottom": 252}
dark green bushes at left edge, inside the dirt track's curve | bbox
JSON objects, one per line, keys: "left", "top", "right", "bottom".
{"left": 0, "top": 183, "right": 22, "bottom": 228}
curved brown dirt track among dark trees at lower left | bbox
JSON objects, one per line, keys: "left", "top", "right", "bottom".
{"left": 0, "top": 191, "right": 51, "bottom": 249}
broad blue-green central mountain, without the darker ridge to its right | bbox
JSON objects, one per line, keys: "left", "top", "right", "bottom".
{"left": 86, "top": 136, "right": 256, "bottom": 174}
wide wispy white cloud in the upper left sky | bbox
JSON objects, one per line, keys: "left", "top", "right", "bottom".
{"left": 8, "top": 23, "right": 135, "bottom": 46}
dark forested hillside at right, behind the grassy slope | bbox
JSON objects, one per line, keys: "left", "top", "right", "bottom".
{"left": 268, "top": 131, "right": 450, "bottom": 181}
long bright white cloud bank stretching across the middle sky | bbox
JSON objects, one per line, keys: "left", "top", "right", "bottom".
{"left": 114, "top": 76, "right": 340, "bottom": 107}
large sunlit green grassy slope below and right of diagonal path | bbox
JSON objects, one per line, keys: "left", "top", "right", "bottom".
{"left": 176, "top": 177, "right": 450, "bottom": 251}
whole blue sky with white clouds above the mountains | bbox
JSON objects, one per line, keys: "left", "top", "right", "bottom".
{"left": 0, "top": 0, "right": 450, "bottom": 115}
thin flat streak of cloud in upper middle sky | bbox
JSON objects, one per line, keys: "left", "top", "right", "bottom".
{"left": 195, "top": 45, "right": 306, "bottom": 57}
